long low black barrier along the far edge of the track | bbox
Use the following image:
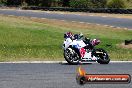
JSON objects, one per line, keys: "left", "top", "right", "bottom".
{"left": 22, "top": 6, "right": 132, "bottom": 14}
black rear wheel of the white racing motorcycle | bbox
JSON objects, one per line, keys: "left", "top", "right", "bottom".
{"left": 96, "top": 48, "right": 110, "bottom": 64}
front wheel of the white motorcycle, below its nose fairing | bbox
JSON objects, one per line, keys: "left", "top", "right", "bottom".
{"left": 64, "top": 48, "right": 79, "bottom": 65}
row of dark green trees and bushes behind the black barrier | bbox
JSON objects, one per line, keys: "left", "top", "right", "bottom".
{"left": 0, "top": 0, "right": 129, "bottom": 8}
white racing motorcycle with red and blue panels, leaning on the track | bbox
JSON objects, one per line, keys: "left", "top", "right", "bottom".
{"left": 63, "top": 35, "right": 110, "bottom": 65}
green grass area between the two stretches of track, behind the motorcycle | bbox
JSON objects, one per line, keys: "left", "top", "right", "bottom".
{"left": 0, "top": 16, "right": 132, "bottom": 61}
